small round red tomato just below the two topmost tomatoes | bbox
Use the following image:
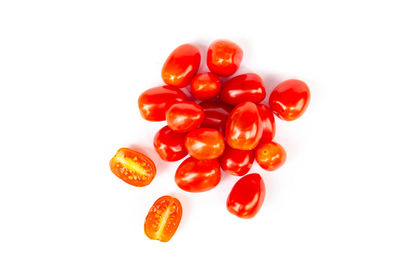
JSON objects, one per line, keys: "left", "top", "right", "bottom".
{"left": 190, "top": 72, "right": 221, "bottom": 100}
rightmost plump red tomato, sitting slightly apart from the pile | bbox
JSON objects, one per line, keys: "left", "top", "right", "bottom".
{"left": 269, "top": 79, "right": 310, "bottom": 121}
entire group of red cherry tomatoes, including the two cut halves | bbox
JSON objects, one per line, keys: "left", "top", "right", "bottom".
{"left": 110, "top": 40, "right": 310, "bottom": 242}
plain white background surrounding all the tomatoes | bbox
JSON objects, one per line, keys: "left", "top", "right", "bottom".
{"left": 0, "top": 0, "right": 400, "bottom": 267}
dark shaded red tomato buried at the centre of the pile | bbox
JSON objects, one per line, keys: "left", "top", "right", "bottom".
{"left": 200, "top": 101, "right": 232, "bottom": 133}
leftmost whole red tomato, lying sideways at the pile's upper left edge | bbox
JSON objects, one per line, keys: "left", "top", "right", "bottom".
{"left": 138, "top": 85, "right": 186, "bottom": 121}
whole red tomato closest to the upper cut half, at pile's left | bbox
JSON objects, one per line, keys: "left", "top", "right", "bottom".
{"left": 153, "top": 126, "right": 187, "bottom": 161}
